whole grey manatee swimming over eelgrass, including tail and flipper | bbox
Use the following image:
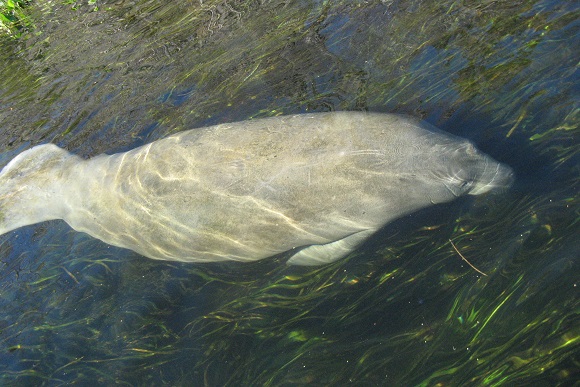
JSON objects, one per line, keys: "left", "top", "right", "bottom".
{"left": 0, "top": 112, "right": 512, "bottom": 265}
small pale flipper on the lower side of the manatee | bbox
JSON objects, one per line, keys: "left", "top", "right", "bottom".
{"left": 287, "top": 230, "right": 376, "bottom": 266}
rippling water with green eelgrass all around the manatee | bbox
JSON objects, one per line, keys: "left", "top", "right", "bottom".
{"left": 0, "top": 1, "right": 580, "bottom": 386}
